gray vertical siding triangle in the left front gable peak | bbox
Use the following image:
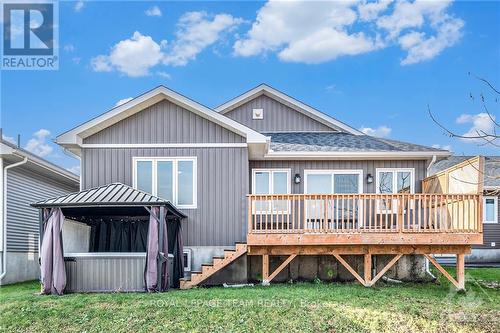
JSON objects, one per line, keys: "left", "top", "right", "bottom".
{"left": 84, "top": 100, "right": 245, "bottom": 144}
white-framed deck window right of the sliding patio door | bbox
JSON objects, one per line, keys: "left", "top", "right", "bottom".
{"left": 376, "top": 168, "right": 415, "bottom": 211}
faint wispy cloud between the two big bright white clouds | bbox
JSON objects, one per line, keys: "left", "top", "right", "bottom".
{"left": 163, "top": 12, "right": 243, "bottom": 66}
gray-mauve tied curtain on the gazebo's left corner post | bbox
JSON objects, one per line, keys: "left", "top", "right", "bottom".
{"left": 40, "top": 208, "right": 66, "bottom": 295}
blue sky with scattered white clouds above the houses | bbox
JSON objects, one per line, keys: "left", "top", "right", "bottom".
{"left": 1, "top": 1, "right": 500, "bottom": 171}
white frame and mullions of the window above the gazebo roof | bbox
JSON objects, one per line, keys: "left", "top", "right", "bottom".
{"left": 132, "top": 156, "right": 198, "bottom": 209}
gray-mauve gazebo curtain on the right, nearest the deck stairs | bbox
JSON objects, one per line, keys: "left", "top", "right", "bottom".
{"left": 144, "top": 207, "right": 168, "bottom": 292}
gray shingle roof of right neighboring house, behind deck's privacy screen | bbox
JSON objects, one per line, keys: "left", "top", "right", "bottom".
{"left": 429, "top": 156, "right": 500, "bottom": 187}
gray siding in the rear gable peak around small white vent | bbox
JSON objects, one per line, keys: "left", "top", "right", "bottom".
{"left": 224, "top": 95, "right": 335, "bottom": 132}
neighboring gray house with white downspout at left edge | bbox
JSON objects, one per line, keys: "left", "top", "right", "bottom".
{"left": 0, "top": 140, "right": 79, "bottom": 285}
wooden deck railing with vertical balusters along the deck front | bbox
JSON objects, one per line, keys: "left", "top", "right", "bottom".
{"left": 248, "top": 194, "right": 482, "bottom": 234}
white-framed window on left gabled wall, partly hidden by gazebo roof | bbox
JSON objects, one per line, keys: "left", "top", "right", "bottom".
{"left": 134, "top": 157, "right": 196, "bottom": 208}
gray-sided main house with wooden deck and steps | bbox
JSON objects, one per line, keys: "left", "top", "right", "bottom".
{"left": 56, "top": 85, "right": 482, "bottom": 287}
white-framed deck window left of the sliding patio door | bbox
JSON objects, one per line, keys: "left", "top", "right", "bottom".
{"left": 252, "top": 169, "right": 291, "bottom": 213}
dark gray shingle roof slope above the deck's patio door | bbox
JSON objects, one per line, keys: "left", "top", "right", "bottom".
{"left": 264, "top": 132, "right": 443, "bottom": 152}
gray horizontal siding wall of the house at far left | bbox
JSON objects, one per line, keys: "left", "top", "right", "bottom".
{"left": 7, "top": 167, "right": 78, "bottom": 252}
